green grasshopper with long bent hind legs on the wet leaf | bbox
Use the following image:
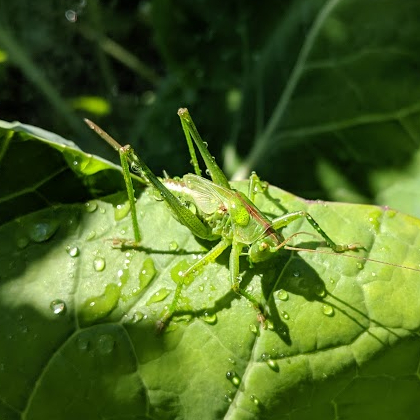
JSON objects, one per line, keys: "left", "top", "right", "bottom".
{"left": 85, "top": 108, "right": 361, "bottom": 329}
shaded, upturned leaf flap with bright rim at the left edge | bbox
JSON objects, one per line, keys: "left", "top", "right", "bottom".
{"left": 0, "top": 120, "right": 130, "bottom": 224}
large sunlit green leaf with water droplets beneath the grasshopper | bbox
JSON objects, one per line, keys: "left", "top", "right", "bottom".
{"left": 0, "top": 124, "right": 420, "bottom": 420}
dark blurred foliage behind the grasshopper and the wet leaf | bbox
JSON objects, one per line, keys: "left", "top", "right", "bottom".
{"left": 0, "top": 0, "right": 420, "bottom": 216}
